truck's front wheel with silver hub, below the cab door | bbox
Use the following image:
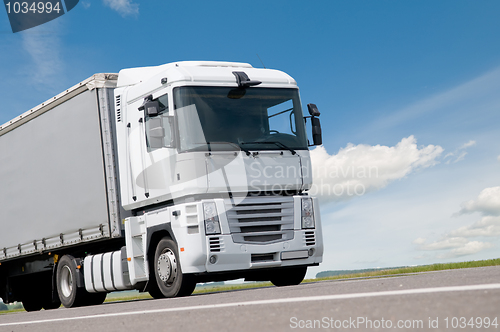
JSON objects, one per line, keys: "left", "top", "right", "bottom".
{"left": 150, "top": 237, "right": 196, "bottom": 298}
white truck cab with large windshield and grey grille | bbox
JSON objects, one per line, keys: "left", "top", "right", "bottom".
{"left": 107, "top": 62, "right": 323, "bottom": 296}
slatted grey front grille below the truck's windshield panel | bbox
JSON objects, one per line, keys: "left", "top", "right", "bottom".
{"left": 225, "top": 197, "right": 294, "bottom": 244}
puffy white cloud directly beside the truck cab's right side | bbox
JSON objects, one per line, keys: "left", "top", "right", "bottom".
{"left": 311, "top": 136, "right": 443, "bottom": 201}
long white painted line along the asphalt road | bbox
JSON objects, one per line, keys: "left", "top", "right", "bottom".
{"left": 0, "top": 284, "right": 500, "bottom": 327}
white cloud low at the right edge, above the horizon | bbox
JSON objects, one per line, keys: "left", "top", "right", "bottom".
{"left": 413, "top": 187, "right": 500, "bottom": 258}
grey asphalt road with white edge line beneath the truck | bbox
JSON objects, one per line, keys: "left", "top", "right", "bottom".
{"left": 0, "top": 267, "right": 500, "bottom": 332}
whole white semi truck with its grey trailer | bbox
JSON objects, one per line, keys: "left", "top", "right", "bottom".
{"left": 0, "top": 61, "right": 323, "bottom": 311}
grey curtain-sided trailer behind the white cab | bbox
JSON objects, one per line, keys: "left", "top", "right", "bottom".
{"left": 0, "top": 74, "right": 129, "bottom": 309}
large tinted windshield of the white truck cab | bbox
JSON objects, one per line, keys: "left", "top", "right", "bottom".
{"left": 174, "top": 87, "right": 307, "bottom": 153}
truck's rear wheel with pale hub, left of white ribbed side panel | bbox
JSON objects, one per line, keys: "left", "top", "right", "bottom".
{"left": 57, "top": 255, "right": 87, "bottom": 308}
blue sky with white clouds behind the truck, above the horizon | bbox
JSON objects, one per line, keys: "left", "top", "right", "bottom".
{"left": 0, "top": 0, "right": 500, "bottom": 275}
